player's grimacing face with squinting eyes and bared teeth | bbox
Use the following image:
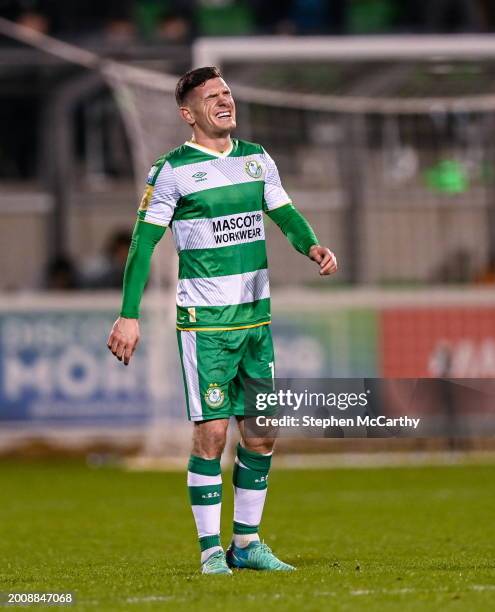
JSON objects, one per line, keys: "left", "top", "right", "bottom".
{"left": 181, "top": 77, "right": 236, "bottom": 136}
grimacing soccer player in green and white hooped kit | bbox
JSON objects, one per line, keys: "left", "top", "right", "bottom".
{"left": 108, "top": 67, "right": 337, "bottom": 574}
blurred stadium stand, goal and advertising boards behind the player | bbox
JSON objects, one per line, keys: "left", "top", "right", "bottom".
{"left": 0, "top": 0, "right": 495, "bottom": 459}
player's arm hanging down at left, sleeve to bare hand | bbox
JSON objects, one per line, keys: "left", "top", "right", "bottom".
{"left": 107, "top": 162, "right": 179, "bottom": 365}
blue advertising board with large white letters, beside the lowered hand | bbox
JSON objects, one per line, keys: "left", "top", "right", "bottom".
{"left": 0, "top": 310, "right": 150, "bottom": 425}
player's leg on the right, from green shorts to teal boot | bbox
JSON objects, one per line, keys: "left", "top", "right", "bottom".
{"left": 227, "top": 326, "right": 294, "bottom": 571}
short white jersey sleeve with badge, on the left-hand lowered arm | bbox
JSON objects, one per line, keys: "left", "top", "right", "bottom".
{"left": 138, "top": 161, "right": 180, "bottom": 227}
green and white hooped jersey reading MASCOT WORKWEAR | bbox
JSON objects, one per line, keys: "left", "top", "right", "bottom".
{"left": 138, "top": 139, "right": 291, "bottom": 330}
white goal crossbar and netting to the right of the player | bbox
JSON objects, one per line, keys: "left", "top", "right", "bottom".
{"left": 194, "top": 36, "right": 495, "bottom": 284}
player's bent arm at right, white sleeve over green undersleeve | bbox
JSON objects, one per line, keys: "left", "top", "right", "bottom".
{"left": 264, "top": 151, "right": 337, "bottom": 276}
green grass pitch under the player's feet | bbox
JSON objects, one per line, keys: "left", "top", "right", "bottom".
{"left": 0, "top": 462, "right": 495, "bottom": 612}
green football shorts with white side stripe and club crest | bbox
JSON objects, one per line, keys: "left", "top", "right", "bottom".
{"left": 177, "top": 325, "right": 275, "bottom": 421}
